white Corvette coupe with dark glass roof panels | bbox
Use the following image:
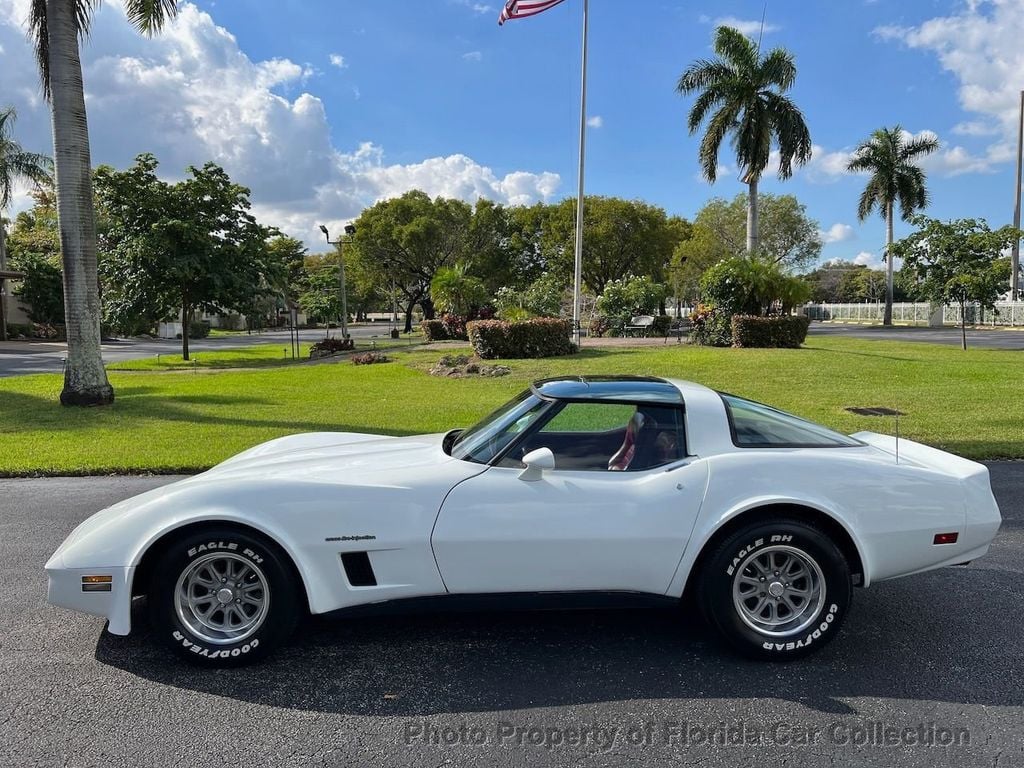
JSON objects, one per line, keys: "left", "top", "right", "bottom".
{"left": 46, "top": 377, "right": 1000, "bottom": 665}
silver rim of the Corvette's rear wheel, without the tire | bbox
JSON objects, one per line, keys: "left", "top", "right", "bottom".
{"left": 732, "top": 545, "right": 825, "bottom": 637}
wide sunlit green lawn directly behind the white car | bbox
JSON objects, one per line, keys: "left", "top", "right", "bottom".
{"left": 0, "top": 338, "right": 1024, "bottom": 475}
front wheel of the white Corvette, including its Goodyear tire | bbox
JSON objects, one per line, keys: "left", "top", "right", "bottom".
{"left": 148, "top": 528, "right": 300, "bottom": 667}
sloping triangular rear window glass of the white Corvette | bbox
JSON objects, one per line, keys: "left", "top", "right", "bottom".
{"left": 719, "top": 392, "right": 864, "bottom": 447}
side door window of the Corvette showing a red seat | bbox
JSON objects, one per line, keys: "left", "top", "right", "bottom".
{"left": 503, "top": 402, "right": 686, "bottom": 472}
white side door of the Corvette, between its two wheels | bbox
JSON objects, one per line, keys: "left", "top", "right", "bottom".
{"left": 431, "top": 403, "right": 708, "bottom": 594}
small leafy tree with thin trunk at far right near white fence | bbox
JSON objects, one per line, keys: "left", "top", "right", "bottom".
{"left": 890, "top": 216, "right": 1022, "bottom": 349}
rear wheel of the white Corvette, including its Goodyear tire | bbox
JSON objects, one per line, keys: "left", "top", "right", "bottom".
{"left": 697, "top": 519, "right": 852, "bottom": 660}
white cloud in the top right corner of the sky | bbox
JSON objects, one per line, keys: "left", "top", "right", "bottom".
{"left": 876, "top": 0, "right": 1024, "bottom": 174}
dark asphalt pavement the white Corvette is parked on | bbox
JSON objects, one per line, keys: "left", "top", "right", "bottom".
{"left": 0, "top": 463, "right": 1024, "bottom": 768}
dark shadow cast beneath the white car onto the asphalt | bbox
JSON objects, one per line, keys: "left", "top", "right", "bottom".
{"left": 96, "top": 567, "right": 1024, "bottom": 717}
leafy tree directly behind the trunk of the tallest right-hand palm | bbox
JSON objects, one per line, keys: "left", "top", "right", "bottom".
{"left": 693, "top": 194, "right": 822, "bottom": 269}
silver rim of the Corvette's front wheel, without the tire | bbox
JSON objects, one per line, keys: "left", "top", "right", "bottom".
{"left": 174, "top": 552, "right": 270, "bottom": 645}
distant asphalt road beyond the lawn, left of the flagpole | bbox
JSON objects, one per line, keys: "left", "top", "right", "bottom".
{"left": 0, "top": 323, "right": 388, "bottom": 378}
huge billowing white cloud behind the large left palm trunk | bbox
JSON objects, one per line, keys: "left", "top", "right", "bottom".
{"left": 0, "top": 0, "right": 560, "bottom": 244}
